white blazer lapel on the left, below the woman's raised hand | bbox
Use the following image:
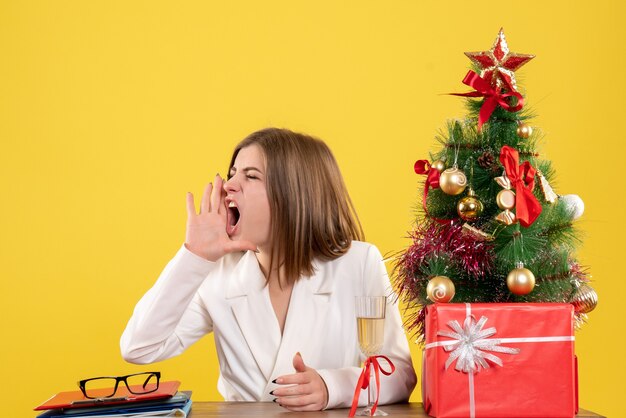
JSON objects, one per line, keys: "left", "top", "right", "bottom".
{"left": 226, "top": 251, "right": 281, "bottom": 380}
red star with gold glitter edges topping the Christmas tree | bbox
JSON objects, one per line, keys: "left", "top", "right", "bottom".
{"left": 465, "top": 29, "right": 535, "bottom": 90}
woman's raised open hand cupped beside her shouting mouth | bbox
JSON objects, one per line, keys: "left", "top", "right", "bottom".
{"left": 185, "top": 174, "right": 257, "bottom": 261}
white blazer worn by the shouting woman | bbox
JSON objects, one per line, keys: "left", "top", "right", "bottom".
{"left": 120, "top": 241, "right": 417, "bottom": 408}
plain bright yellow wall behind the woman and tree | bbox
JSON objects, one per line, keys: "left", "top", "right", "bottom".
{"left": 0, "top": 0, "right": 626, "bottom": 417}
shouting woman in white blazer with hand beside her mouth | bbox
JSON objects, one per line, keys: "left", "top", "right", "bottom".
{"left": 121, "top": 128, "right": 416, "bottom": 411}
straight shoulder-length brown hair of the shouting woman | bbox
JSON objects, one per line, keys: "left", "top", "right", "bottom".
{"left": 228, "top": 128, "right": 364, "bottom": 283}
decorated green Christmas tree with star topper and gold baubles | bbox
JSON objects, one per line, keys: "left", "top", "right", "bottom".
{"left": 394, "top": 29, "right": 597, "bottom": 341}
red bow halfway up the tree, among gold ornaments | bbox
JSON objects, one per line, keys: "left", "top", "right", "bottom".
{"left": 500, "top": 145, "right": 542, "bottom": 228}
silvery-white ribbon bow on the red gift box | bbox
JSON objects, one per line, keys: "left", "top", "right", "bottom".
{"left": 437, "top": 315, "right": 520, "bottom": 373}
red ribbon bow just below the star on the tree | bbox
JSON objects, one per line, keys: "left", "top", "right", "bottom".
{"left": 450, "top": 70, "right": 524, "bottom": 132}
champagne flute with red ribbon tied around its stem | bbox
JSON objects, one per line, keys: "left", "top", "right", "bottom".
{"left": 355, "top": 296, "right": 387, "bottom": 416}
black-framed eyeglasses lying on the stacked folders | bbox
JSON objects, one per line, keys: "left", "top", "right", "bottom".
{"left": 78, "top": 372, "right": 161, "bottom": 399}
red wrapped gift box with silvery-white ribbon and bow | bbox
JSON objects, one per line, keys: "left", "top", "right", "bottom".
{"left": 422, "top": 303, "right": 578, "bottom": 418}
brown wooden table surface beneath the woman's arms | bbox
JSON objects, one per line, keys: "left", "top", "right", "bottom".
{"left": 189, "top": 402, "right": 602, "bottom": 418}
